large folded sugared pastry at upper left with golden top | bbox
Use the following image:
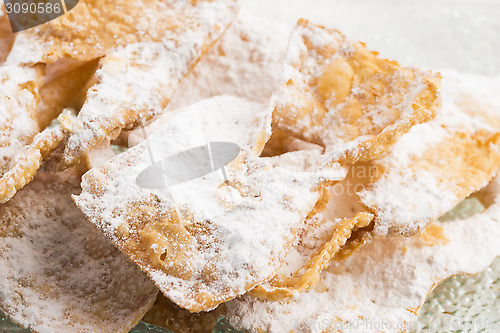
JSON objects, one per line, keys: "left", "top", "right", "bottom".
{"left": 0, "top": 0, "right": 236, "bottom": 202}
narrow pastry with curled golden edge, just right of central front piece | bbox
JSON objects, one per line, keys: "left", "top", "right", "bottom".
{"left": 248, "top": 160, "right": 374, "bottom": 301}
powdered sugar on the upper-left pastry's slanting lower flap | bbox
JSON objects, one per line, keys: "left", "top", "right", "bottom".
{"left": 61, "top": 0, "right": 236, "bottom": 165}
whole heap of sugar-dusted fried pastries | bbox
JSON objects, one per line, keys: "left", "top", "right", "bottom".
{"left": 0, "top": 0, "right": 500, "bottom": 332}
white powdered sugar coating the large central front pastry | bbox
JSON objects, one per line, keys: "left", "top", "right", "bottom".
{"left": 75, "top": 96, "right": 344, "bottom": 311}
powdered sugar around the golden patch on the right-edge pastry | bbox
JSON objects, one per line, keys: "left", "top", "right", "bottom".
{"left": 360, "top": 71, "right": 500, "bottom": 235}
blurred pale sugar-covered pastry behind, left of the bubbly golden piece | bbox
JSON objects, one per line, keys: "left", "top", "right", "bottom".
{"left": 167, "top": 9, "right": 291, "bottom": 110}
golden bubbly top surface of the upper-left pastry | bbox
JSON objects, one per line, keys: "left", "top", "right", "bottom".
{"left": 11, "top": 0, "right": 234, "bottom": 64}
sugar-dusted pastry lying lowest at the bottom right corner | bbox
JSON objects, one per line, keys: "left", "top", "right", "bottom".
{"left": 226, "top": 179, "right": 500, "bottom": 333}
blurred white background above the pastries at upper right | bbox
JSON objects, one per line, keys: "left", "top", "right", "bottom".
{"left": 243, "top": 0, "right": 500, "bottom": 75}
